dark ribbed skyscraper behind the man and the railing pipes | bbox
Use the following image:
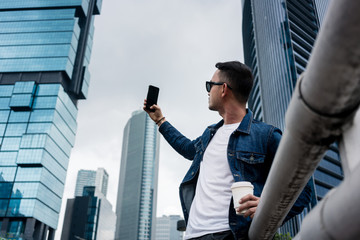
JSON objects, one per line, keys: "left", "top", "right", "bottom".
{"left": 242, "top": 0, "right": 343, "bottom": 235}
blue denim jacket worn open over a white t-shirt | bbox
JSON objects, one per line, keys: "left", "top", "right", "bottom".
{"left": 159, "top": 110, "right": 311, "bottom": 239}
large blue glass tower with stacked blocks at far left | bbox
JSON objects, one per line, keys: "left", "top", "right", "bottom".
{"left": 0, "top": 0, "right": 102, "bottom": 240}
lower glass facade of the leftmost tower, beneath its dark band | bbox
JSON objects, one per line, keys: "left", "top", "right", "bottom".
{"left": 0, "top": 82, "right": 77, "bottom": 231}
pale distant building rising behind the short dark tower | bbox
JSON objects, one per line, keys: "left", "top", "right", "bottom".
{"left": 75, "top": 168, "right": 109, "bottom": 197}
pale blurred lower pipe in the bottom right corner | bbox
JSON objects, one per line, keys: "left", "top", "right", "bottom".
{"left": 294, "top": 109, "right": 360, "bottom": 240}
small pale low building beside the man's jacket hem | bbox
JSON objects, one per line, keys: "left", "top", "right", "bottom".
{"left": 155, "top": 215, "right": 183, "bottom": 240}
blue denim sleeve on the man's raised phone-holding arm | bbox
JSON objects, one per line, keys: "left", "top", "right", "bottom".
{"left": 159, "top": 121, "right": 200, "bottom": 160}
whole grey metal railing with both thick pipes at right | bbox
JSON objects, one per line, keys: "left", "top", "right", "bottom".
{"left": 249, "top": 0, "right": 360, "bottom": 240}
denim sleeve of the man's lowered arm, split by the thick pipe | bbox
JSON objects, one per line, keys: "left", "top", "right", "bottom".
{"left": 269, "top": 128, "right": 313, "bottom": 223}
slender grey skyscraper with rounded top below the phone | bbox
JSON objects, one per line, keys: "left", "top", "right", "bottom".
{"left": 115, "top": 110, "right": 159, "bottom": 240}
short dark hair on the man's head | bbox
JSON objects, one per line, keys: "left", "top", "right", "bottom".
{"left": 215, "top": 61, "right": 254, "bottom": 103}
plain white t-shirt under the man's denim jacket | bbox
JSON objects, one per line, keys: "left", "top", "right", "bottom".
{"left": 185, "top": 123, "right": 240, "bottom": 239}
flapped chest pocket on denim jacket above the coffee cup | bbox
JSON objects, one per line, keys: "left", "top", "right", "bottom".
{"left": 235, "top": 151, "right": 267, "bottom": 182}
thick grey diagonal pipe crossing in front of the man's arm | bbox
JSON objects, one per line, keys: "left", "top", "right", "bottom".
{"left": 249, "top": 0, "right": 360, "bottom": 237}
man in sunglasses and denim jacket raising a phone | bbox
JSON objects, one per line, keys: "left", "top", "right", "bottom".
{"left": 144, "top": 61, "right": 311, "bottom": 240}
